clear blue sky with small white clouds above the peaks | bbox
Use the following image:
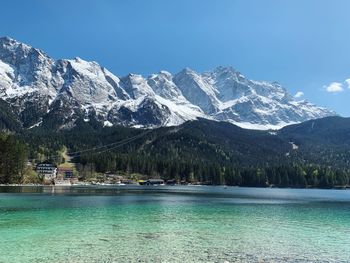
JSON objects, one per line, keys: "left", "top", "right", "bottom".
{"left": 0, "top": 0, "right": 350, "bottom": 117}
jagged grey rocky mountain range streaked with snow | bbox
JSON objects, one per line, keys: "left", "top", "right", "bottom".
{"left": 0, "top": 37, "right": 335, "bottom": 129}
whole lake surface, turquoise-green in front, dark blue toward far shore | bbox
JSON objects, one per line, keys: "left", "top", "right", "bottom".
{"left": 0, "top": 186, "right": 350, "bottom": 263}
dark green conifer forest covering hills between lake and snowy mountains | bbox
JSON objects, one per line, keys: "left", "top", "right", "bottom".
{"left": 0, "top": 117, "right": 350, "bottom": 188}
